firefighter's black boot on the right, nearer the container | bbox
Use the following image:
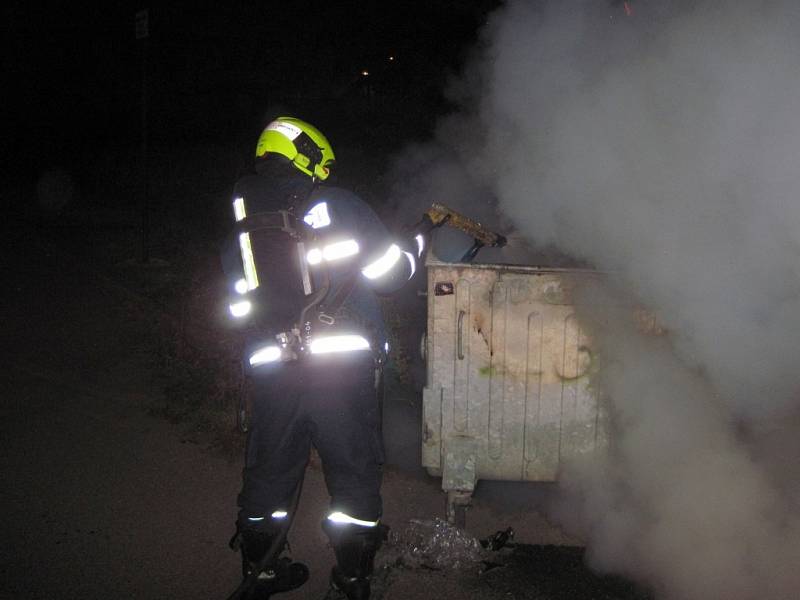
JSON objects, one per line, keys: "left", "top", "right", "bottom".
{"left": 322, "top": 520, "right": 383, "bottom": 600}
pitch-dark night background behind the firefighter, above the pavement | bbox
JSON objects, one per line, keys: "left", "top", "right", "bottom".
{"left": 0, "top": 0, "right": 498, "bottom": 450}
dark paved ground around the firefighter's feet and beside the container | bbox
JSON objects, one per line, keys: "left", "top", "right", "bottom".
{"left": 0, "top": 221, "right": 644, "bottom": 600}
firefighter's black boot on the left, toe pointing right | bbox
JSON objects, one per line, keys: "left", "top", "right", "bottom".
{"left": 239, "top": 530, "right": 309, "bottom": 600}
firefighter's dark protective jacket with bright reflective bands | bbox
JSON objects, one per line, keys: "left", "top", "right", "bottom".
{"left": 223, "top": 169, "right": 416, "bottom": 360}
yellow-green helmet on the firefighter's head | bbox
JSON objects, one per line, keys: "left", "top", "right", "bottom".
{"left": 256, "top": 117, "right": 335, "bottom": 179}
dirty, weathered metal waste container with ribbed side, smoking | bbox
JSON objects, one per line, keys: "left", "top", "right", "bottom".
{"left": 422, "top": 257, "right": 608, "bottom": 526}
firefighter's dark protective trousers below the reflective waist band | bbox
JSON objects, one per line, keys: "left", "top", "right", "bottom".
{"left": 239, "top": 351, "right": 383, "bottom": 533}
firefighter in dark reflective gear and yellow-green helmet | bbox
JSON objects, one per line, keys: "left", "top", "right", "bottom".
{"left": 223, "top": 117, "right": 416, "bottom": 600}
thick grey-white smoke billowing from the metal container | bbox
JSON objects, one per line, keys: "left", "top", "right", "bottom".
{"left": 396, "top": 0, "right": 800, "bottom": 600}
